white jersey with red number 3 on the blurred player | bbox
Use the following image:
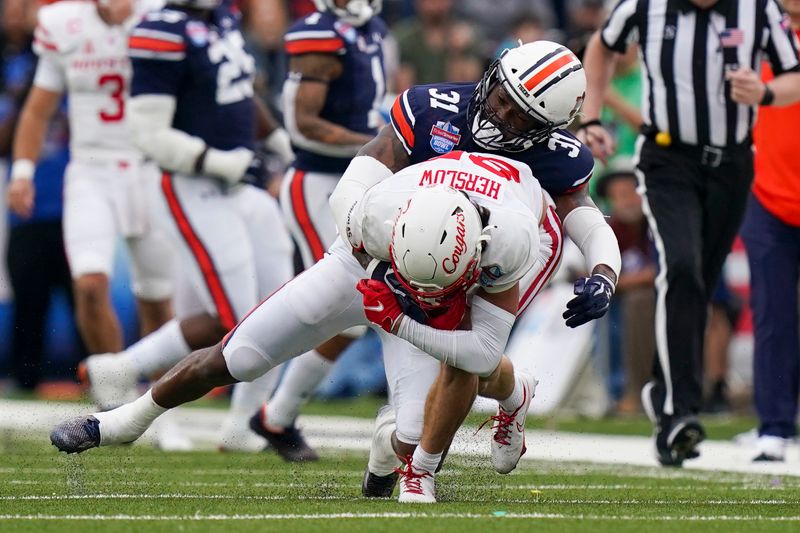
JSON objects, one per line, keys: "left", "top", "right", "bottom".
{"left": 34, "top": 0, "right": 163, "bottom": 159}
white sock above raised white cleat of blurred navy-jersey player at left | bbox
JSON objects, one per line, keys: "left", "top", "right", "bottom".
{"left": 126, "top": 318, "right": 192, "bottom": 377}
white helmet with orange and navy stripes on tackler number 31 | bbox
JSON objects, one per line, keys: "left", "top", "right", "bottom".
{"left": 469, "top": 41, "right": 586, "bottom": 152}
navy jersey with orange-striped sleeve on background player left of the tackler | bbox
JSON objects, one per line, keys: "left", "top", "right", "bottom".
{"left": 283, "top": 12, "right": 386, "bottom": 174}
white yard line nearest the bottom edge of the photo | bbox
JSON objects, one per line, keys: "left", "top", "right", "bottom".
{"left": 0, "top": 512, "right": 800, "bottom": 522}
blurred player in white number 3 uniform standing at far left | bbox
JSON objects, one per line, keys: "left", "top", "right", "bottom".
{"left": 8, "top": 0, "right": 173, "bottom": 353}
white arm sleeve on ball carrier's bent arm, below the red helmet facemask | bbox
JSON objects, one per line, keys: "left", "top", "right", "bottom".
{"left": 397, "top": 296, "right": 514, "bottom": 377}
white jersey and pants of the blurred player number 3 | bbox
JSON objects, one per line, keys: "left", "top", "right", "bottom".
{"left": 34, "top": 0, "right": 172, "bottom": 299}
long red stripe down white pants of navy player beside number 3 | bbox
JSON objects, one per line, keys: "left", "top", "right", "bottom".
{"left": 161, "top": 172, "right": 236, "bottom": 329}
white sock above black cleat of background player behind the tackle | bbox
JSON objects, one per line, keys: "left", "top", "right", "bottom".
{"left": 267, "top": 350, "right": 333, "bottom": 428}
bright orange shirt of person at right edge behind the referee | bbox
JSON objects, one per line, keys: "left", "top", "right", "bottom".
{"left": 753, "top": 30, "right": 800, "bottom": 226}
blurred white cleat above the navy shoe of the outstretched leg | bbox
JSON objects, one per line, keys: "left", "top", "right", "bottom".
{"left": 78, "top": 353, "right": 139, "bottom": 411}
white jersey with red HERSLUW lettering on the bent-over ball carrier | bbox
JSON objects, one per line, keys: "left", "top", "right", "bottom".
{"left": 358, "top": 151, "right": 547, "bottom": 292}
